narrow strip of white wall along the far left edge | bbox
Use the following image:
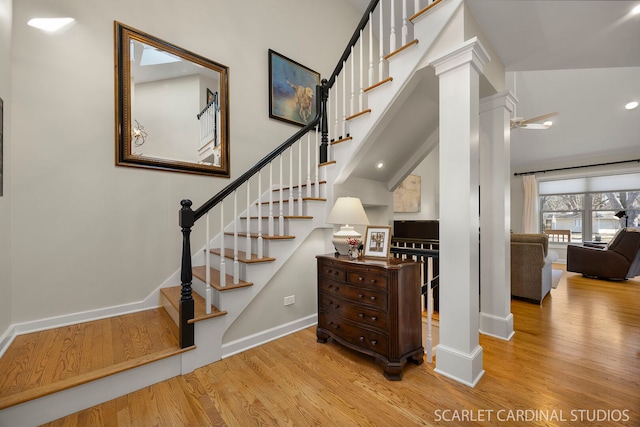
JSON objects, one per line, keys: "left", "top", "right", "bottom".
{"left": 0, "top": 0, "right": 12, "bottom": 336}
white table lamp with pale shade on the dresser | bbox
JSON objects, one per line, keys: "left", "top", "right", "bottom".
{"left": 327, "top": 197, "right": 369, "bottom": 255}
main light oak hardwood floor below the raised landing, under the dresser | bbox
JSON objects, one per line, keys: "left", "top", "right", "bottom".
{"left": 37, "top": 273, "right": 640, "bottom": 427}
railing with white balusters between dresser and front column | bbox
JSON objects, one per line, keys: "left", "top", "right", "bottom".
{"left": 390, "top": 237, "right": 440, "bottom": 363}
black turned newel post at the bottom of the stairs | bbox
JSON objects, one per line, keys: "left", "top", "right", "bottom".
{"left": 178, "top": 200, "right": 195, "bottom": 348}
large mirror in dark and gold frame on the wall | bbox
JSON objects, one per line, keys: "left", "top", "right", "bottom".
{"left": 114, "top": 21, "right": 230, "bottom": 178}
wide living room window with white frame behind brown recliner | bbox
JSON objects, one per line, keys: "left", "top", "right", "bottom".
{"left": 539, "top": 174, "right": 640, "bottom": 243}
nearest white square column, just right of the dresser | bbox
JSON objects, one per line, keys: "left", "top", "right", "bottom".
{"left": 431, "top": 37, "right": 489, "bottom": 387}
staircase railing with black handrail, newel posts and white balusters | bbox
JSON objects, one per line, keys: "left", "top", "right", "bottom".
{"left": 179, "top": 0, "right": 441, "bottom": 348}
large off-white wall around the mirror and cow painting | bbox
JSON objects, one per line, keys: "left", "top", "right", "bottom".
{"left": 7, "top": 0, "right": 360, "bottom": 331}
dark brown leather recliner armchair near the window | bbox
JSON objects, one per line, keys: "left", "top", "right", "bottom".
{"left": 567, "top": 227, "right": 640, "bottom": 280}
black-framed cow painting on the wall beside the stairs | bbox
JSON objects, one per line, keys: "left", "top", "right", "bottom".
{"left": 269, "top": 49, "right": 320, "bottom": 126}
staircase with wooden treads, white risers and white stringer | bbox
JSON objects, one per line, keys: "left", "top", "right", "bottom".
{"left": 0, "top": 0, "right": 463, "bottom": 426}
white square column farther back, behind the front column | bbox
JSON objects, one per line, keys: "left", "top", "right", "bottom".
{"left": 480, "top": 91, "right": 517, "bottom": 340}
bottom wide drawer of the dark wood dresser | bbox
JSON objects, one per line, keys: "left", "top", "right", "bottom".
{"left": 318, "top": 313, "right": 389, "bottom": 356}
